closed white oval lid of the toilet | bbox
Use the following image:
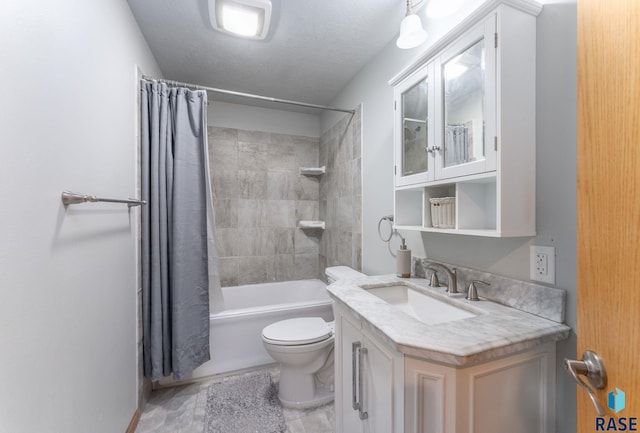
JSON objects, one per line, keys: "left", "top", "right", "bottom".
{"left": 262, "top": 317, "right": 332, "bottom": 346}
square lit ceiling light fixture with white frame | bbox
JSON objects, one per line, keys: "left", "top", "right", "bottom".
{"left": 209, "top": 0, "right": 271, "bottom": 40}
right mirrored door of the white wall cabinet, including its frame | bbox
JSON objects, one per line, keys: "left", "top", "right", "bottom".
{"left": 435, "top": 15, "right": 497, "bottom": 179}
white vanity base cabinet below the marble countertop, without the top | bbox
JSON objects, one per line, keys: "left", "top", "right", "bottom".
{"left": 334, "top": 304, "right": 556, "bottom": 433}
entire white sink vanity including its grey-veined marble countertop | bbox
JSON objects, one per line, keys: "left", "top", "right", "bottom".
{"left": 327, "top": 276, "right": 571, "bottom": 433}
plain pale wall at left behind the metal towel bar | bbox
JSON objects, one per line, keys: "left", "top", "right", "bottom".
{"left": 0, "top": 0, "right": 160, "bottom": 433}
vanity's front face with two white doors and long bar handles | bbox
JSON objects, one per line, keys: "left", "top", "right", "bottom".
{"left": 335, "top": 304, "right": 404, "bottom": 433}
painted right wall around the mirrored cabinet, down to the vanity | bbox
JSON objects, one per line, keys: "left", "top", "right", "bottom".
{"left": 321, "top": 0, "right": 576, "bottom": 432}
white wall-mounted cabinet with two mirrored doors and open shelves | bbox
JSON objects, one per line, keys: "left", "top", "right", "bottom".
{"left": 389, "top": 0, "right": 541, "bottom": 237}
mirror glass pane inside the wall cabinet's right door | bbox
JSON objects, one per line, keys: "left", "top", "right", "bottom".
{"left": 442, "top": 39, "right": 485, "bottom": 167}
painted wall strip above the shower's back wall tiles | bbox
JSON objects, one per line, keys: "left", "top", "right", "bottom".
{"left": 207, "top": 100, "right": 320, "bottom": 138}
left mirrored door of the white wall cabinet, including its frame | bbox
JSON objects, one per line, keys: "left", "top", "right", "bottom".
{"left": 395, "top": 63, "right": 434, "bottom": 185}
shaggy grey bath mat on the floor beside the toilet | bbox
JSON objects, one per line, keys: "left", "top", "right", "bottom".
{"left": 204, "top": 372, "right": 287, "bottom": 433}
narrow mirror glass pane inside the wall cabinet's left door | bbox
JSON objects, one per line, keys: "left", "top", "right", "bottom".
{"left": 402, "top": 78, "right": 429, "bottom": 176}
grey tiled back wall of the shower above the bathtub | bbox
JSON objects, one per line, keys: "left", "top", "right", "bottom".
{"left": 209, "top": 127, "right": 322, "bottom": 287}
